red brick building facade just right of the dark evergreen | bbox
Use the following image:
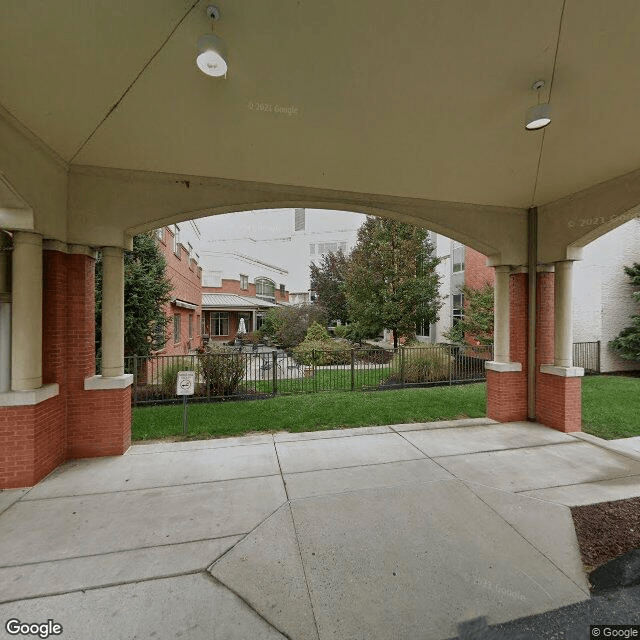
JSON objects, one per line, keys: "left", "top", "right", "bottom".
{"left": 158, "top": 228, "right": 202, "bottom": 356}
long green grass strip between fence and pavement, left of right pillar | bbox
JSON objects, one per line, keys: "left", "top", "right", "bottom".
{"left": 132, "top": 383, "right": 486, "bottom": 440}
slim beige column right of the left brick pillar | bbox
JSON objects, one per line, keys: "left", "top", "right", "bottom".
{"left": 102, "top": 247, "right": 124, "bottom": 378}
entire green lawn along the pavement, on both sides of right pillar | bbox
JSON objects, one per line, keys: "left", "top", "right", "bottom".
{"left": 132, "top": 375, "right": 640, "bottom": 440}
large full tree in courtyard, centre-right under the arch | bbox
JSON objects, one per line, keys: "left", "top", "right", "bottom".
{"left": 346, "top": 217, "right": 441, "bottom": 347}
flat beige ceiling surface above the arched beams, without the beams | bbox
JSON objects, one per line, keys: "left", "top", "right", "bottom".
{"left": 0, "top": 0, "right": 640, "bottom": 207}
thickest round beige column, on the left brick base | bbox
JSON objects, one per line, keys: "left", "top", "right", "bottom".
{"left": 11, "top": 231, "right": 42, "bottom": 391}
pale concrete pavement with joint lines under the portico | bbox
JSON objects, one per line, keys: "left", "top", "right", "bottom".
{"left": 0, "top": 419, "right": 640, "bottom": 640}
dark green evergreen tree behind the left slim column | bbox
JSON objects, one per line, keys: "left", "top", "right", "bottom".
{"left": 96, "top": 233, "right": 173, "bottom": 356}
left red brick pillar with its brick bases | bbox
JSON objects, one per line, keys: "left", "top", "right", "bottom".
{"left": 0, "top": 251, "right": 131, "bottom": 488}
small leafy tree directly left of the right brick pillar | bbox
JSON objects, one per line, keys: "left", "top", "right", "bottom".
{"left": 444, "top": 283, "right": 493, "bottom": 346}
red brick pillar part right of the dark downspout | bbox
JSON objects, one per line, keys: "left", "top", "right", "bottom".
{"left": 536, "top": 272, "right": 582, "bottom": 432}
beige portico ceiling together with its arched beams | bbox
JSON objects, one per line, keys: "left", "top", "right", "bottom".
{"left": 0, "top": 0, "right": 640, "bottom": 264}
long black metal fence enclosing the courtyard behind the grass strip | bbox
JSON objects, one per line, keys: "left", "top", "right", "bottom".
{"left": 125, "top": 344, "right": 492, "bottom": 405}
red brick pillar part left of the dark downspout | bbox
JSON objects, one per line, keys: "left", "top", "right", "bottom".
{"left": 487, "top": 273, "right": 529, "bottom": 422}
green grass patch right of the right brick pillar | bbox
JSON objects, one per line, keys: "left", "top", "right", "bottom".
{"left": 582, "top": 376, "right": 640, "bottom": 440}
